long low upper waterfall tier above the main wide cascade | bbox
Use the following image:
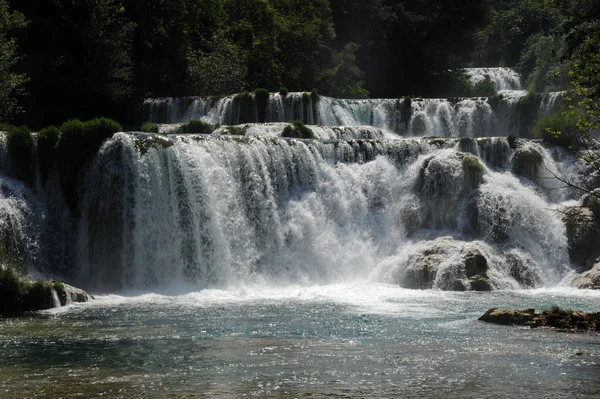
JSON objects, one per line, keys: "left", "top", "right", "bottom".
{"left": 144, "top": 91, "right": 560, "bottom": 137}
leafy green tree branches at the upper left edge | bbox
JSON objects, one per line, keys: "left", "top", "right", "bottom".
{"left": 0, "top": 0, "right": 27, "bottom": 122}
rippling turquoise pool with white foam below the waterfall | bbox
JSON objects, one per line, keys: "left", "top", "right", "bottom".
{"left": 0, "top": 284, "right": 600, "bottom": 399}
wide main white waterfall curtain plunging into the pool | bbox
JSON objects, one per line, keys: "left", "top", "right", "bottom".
{"left": 63, "top": 134, "right": 569, "bottom": 291}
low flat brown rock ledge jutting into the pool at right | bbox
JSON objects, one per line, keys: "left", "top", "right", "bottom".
{"left": 479, "top": 307, "right": 600, "bottom": 332}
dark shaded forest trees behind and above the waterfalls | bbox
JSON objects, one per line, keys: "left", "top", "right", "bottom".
{"left": 0, "top": 0, "right": 600, "bottom": 129}
